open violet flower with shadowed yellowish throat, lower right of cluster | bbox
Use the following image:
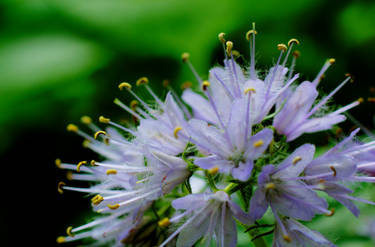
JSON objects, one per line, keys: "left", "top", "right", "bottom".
{"left": 249, "top": 144, "right": 331, "bottom": 221}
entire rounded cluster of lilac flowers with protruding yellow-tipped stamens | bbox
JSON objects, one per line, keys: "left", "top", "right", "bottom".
{"left": 56, "top": 27, "right": 375, "bottom": 247}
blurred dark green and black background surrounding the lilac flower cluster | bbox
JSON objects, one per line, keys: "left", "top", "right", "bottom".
{"left": 0, "top": 0, "right": 375, "bottom": 246}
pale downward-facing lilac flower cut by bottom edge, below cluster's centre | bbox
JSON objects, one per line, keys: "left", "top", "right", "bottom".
{"left": 159, "top": 191, "right": 252, "bottom": 247}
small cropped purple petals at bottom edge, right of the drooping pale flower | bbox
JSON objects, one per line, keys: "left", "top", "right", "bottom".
{"left": 272, "top": 218, "right": 336, "bottom": 247}
